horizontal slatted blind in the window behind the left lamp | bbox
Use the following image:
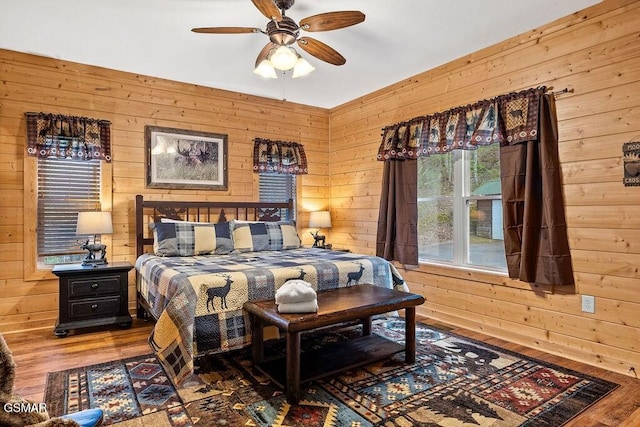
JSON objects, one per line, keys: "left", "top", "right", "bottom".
{"left": 37, "top": 158, "right": 100, "bottom": 257}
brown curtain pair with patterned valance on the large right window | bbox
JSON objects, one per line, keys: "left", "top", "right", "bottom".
{"left": 376, "top": 87, "right": 573, "bottom": 285}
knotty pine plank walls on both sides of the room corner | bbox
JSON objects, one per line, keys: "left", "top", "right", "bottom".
{"left": 0, "top": 0, "right": 640, "bottom": 382}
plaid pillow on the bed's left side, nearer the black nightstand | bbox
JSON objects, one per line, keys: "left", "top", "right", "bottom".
{"left": 149, "top": 222, "right": 233, "bottom": 256}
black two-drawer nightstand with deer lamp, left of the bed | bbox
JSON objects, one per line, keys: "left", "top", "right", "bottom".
{"left": 52, "top": 262, "right": 133, "bottom": 338}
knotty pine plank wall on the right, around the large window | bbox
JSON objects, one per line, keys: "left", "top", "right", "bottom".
{"left": 330, "top": 0, "right": 640, "bottom": 375}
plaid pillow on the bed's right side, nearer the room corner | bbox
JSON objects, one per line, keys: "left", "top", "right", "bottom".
{"left": 231, "top": 221, "right": 301, "bottom": 252}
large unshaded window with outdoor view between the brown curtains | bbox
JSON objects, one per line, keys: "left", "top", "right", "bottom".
{"left": 418, "top": 144, "right": 506, "bottom": 271}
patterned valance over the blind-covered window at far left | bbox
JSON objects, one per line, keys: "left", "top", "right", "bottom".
{"left": 25, "top": 113, "right": 111, "bottom": 162}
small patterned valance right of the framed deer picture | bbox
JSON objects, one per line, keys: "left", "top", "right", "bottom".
{"left": 253, "top": 138, "right": 309, "bottom": 175}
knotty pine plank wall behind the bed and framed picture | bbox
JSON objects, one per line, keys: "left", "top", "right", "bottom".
{"left": 0, "top": 50, "right": 329, "bottom": 332}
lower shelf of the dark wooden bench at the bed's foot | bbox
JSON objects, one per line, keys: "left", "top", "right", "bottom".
{"left": 258, "top": 334, "right": 404, "bottom": 387}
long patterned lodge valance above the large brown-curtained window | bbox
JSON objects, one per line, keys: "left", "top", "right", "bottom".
{"left": 378, "top": 87, "right": 546, "bottom": 161}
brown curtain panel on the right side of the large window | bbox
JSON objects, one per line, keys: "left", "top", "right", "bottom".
{"left": 500, "top": 94, "right": 574, "bottom": 285}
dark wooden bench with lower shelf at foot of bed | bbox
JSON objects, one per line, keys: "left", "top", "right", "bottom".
{"left": 244, "top": 284, "right": 424, "bottom": 404}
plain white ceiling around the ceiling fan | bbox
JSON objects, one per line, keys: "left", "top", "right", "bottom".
{"left": 0, "top": 0, "right": 600, "bottom": 108}
